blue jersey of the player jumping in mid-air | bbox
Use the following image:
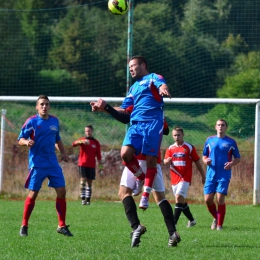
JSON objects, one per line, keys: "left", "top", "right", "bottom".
{"left": 121, "top": 73, "right": 166, "bottom": 122}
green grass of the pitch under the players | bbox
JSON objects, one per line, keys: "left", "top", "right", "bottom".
{"left": 0, "top": 199, "right": 260, "bottom": 260}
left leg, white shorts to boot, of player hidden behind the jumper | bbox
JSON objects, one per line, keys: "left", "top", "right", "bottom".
{"left": 118, "top": 167, "right": 146, "bottom": 247}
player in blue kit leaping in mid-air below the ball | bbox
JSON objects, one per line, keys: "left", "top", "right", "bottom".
{"left": 121, "top": 56, "right": 171, "bottom": 210}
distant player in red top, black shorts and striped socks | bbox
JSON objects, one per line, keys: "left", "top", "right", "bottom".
{"left": 72, "top": 125, "right": 102, "bottom": 205}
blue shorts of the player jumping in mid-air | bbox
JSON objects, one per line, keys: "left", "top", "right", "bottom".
{"left": 123, "top": 120, "right": 163, "bottom": 156}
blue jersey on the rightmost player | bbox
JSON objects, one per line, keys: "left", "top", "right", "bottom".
{"left": 203, "top": 135, "right": 240, "bottom": 181}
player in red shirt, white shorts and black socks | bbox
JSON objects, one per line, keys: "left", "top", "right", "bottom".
{"left": 164, "top": 127, "right": 205, "bottom": 227}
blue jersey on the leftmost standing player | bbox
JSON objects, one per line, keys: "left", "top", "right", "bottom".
{"left": 18, "top": 114, "right": 61, "bottom": 169}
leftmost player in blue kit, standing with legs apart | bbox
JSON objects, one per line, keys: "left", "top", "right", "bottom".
{"left": 18, "top": 95, "right": 73, "bottom": 236}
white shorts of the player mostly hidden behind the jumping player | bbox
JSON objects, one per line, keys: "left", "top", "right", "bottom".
{"left": 120, "top": 160, "right": 165, "bottom": 192}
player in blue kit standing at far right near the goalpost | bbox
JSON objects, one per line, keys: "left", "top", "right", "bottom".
{"left": 202, "top": 119, "right": 240, "bottom": 230}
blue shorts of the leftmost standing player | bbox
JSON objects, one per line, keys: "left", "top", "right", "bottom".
{"left": 24, "top": 166, "right": 65, "bottom": 191}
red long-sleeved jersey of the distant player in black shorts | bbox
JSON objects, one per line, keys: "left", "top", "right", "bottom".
{"left": 72, "top": 137, "right": 101, "bottom": 168}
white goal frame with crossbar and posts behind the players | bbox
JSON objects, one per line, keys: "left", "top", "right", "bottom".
{"left": 0, "top": 96, "right": 260, "bottom": 205}
